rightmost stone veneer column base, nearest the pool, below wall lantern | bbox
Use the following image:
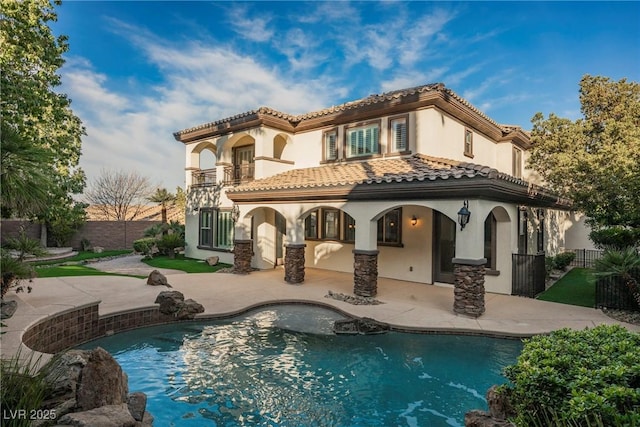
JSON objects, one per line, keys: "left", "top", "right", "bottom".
{"left": 453, "top": 258, "right": 487, "bottom": 317}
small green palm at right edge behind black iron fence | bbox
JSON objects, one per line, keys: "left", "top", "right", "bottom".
{"left": 595, "top": 247, "right": 640, "bottom": 307}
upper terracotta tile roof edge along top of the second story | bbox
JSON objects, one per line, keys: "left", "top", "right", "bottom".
{"left": 173, "top": 83, "right": 520, "bottom": 138}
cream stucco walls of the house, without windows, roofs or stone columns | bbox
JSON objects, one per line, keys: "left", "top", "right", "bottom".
{"left": 179, "top": 107, "right": 591, "bottom": 293}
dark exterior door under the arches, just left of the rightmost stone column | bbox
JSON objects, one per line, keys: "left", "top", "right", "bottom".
{"left": 433, "top": 212, "right": 456, "bottom": 283}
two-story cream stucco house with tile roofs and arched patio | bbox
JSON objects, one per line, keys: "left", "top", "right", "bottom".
{"left": 174, "top": 84, "right": 570, "bottom": 316}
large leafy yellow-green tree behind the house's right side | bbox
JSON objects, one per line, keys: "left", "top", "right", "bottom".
{"left": 528, "top": 75, "right": 640, "bottom": 228}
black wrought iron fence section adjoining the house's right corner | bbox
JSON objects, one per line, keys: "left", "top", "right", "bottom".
{"left": 511, "top": 254, "right": 546, "bottom": 298}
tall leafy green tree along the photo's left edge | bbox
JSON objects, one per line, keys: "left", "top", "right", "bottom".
{"left": 0, "top": 0, "right": 85, "bottom": 227}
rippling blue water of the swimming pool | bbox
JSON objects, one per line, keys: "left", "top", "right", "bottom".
{"left": 83, "top": 305, "right": 522, "bottom": 427}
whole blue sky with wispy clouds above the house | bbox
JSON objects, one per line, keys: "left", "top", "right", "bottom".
{"left": 51, "top": 1, "right": 640, "bottom": 191}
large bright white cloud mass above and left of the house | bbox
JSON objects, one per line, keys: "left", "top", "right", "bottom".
{"left": 62, "top": 24, "right": 344, "bottom": 190}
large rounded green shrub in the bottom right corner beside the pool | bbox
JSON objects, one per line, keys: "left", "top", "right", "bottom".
{"left": 501, "top": 325, "right": 640, "bottom": 426}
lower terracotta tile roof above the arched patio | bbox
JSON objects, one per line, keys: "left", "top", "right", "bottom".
{"left": 227, "top": 154, "right": 526, "bottom": 194}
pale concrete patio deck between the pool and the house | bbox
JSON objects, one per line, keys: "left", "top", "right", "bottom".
{"left": 0, "top": 260, "right": 640, "bottom": 364}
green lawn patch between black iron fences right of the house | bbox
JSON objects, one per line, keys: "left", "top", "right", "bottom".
{"left": 538, "top": 268, "right": 596, "bottom": 307}
